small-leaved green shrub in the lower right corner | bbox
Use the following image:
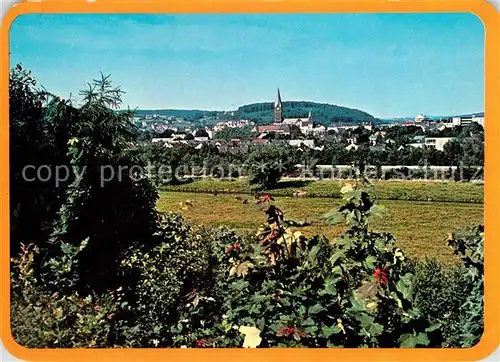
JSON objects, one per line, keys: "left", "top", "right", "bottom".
{"left": 409, "top": 226, "right": 484, "bottom": 347}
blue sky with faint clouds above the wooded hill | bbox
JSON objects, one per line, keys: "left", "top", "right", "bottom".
{"left": 10, "top": 13, "right": 484, "bottom": 117}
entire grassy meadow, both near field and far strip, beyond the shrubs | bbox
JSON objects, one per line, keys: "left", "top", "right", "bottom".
{"left": 157, "top": 187, "right": 483, "bottom": 264}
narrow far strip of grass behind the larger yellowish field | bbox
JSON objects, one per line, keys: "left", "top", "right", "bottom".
{"left": 162, "top": 179, "right": 484, "bottom": 204}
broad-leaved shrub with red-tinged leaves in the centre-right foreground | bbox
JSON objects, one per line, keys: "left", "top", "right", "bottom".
{"left": 213, "top": 190, "right": 439, "bottom": 347}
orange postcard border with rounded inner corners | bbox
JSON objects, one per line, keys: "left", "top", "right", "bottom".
{"left": 0, "top": 0, "right": 500, "bottom": 362}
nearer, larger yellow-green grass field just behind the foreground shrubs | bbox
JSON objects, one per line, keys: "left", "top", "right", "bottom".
{"left": 158, "top": 191, "right": 483, "bottom": 263}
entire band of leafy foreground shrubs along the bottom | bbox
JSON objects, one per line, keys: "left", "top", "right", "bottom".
{"left": 12, "top": 187, "right": 483, "bottom": 348}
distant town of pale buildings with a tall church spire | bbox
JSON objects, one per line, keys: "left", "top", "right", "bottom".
{"left": 134, "top": 89, "right": 484, "bottom": 156}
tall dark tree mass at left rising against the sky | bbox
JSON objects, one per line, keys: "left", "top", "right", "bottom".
{"left": 10, "top": 66, "right": 158, "bottom": 292}
